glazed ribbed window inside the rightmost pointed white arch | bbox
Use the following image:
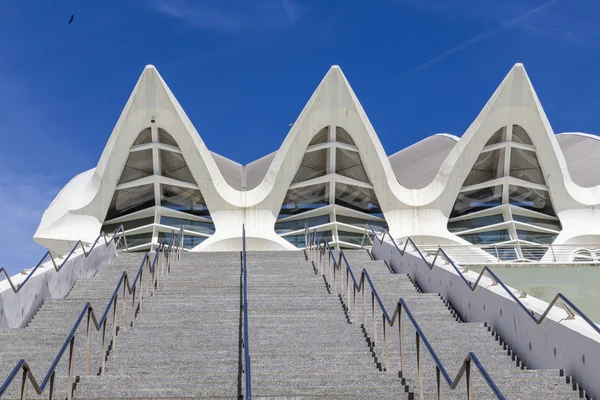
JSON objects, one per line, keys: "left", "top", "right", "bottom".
{"left": 447, "top": 125, "right": 562, "bottom": 260}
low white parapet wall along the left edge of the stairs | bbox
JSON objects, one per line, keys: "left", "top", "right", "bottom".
{"left": 0, "top": 241, "right": 117, "bottom": 328}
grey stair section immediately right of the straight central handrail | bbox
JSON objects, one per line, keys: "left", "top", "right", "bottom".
{"left": 247, "top": 251, "right": 408, "bottom": 399}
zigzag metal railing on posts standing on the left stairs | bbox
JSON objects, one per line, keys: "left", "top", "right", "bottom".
{"left": 0, "top": 228, "right": 183, "bottom": 400}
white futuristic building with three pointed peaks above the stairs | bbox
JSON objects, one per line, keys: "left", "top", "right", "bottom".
{"left": 34, "top": 64, "right": 600, "bottom": 258}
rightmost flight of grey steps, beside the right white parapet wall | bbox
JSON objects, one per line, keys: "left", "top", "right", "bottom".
{"left": 344, "top": 250, "right": 580, "bottom": 400}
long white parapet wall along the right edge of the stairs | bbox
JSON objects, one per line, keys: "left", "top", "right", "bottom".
{"left": 372, "top": 240, "right": 600, "bottom": 398}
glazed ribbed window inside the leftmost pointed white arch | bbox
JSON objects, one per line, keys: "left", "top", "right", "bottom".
{"left": 103, "top": 126, "right": 215, "bottom": 251}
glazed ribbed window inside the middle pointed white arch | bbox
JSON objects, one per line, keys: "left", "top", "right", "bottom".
{"left": 275, "top": 122, "right": 387, "bottom": 248}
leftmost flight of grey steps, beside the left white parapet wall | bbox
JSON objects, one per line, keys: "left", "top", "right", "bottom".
{"left": 0, "top": 253, "right": 144, "bottom": 398}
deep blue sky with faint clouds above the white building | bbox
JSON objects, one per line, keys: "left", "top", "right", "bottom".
{"left": 0, "top": 0, "right": 600, "bottom": 272}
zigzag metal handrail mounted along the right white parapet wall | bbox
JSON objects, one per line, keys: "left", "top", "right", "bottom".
{"left": 365, "top": 224, "right": 600, "bottom": 334}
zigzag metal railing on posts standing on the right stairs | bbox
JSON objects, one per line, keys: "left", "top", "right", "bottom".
{"left": 311, "top": 231, "right": 505, "bottom": 400}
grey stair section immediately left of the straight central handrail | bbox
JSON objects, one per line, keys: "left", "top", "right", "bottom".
{"left": 75, "top": 252, "right": 241, "bottom": 399}
